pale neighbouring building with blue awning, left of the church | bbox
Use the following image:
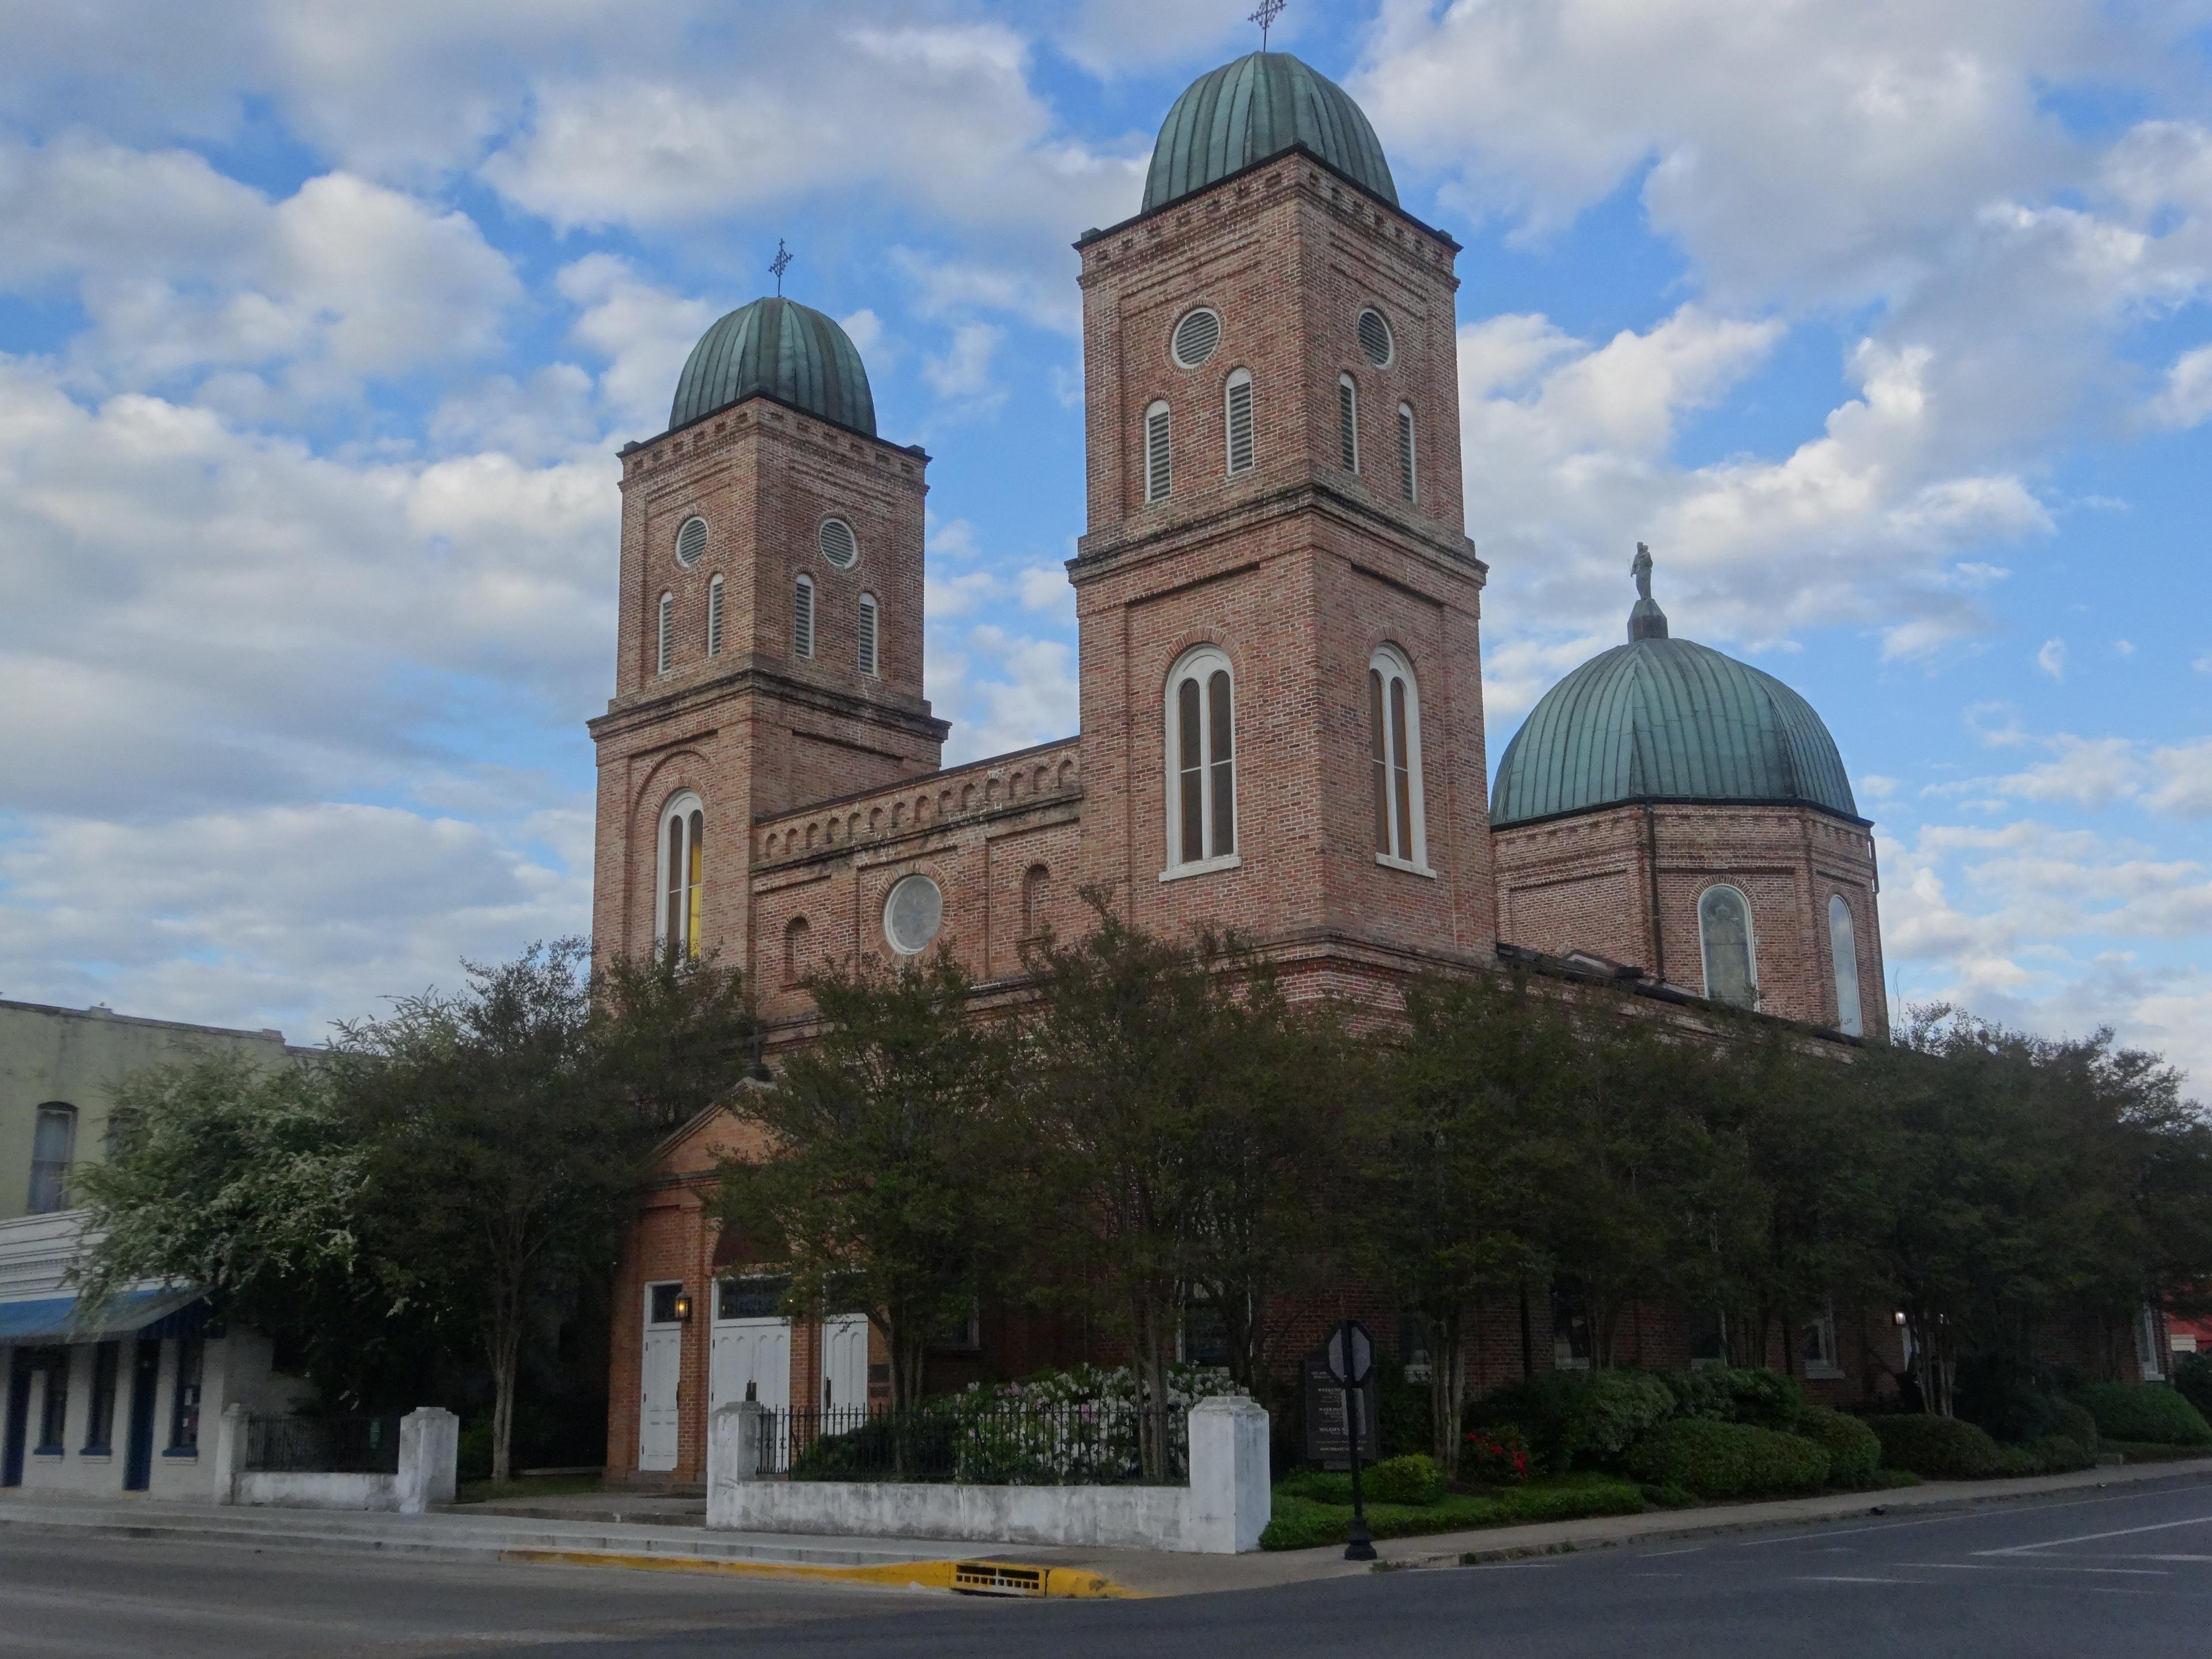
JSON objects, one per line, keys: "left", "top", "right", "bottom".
{"left": 0, "top": 1002, "right": 314, "bottom": 1498}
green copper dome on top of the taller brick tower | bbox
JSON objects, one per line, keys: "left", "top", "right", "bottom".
{"left": 1143, "top": 51, "right": 1398, "bottom": 213}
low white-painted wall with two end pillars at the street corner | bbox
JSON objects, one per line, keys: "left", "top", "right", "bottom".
{"left": 706, "top": 1398, "right": 1270, "bottom": 1555}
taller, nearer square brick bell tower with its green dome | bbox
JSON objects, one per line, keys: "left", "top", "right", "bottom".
{"left": 1069, "top": 53, "right": 1495, "bottom": 975}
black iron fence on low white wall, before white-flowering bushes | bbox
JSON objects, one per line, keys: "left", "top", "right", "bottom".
{"left": 761, "top": 1400, "right": 1190, "bottom": 1486}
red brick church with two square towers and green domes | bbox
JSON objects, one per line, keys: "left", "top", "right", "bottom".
{"left": 590, "top": 53, "right": 1885, "bottom": 1480}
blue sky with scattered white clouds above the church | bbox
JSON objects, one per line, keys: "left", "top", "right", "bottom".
{"left": 0, "top": 0, "right": 2212, "bottom": 1093}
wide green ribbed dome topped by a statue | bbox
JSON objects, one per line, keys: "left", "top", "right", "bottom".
{"left": 1491, "top": 544, "right": 1858, "bottom": 830}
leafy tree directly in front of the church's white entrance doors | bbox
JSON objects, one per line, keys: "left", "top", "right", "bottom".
{"left": 717, "top": 951, "right": 1013, "bottom": 1404}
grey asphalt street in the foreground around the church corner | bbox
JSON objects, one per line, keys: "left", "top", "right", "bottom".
{"left": 0, "top": 1482, "right": 2212, "bottom": 1659}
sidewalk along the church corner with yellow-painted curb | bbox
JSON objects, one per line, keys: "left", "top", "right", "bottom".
{"left": 0, "top": 1460, "right": 2212, "bottom": 1597}
